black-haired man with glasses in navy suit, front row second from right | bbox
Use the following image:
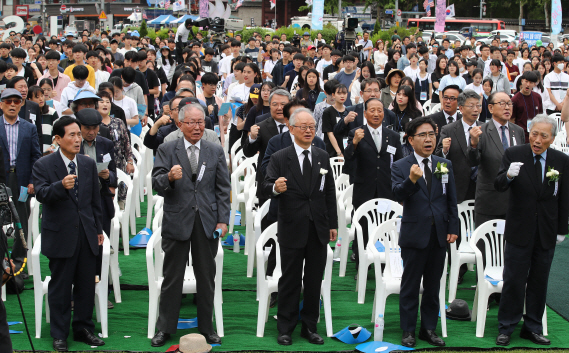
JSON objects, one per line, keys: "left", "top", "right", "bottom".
{"left": 391, "top": 117, "right": 459, "bottom": 347}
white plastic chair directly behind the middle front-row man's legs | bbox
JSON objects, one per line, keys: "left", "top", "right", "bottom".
{"left": 256, "top": 223, "right": 334, "bottom": 337}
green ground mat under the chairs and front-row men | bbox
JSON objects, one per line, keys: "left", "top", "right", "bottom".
{"left": 6, "top": 197, "right": 569, "bottom": 352}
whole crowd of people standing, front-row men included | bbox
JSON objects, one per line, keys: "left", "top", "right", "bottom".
{"left": 0, "top": 21, "right": 569, "bottom": 351}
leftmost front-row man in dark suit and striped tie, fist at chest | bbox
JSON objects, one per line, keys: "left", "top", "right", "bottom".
{"left": 33, "top": 117, "right": 105, "bottom": 352}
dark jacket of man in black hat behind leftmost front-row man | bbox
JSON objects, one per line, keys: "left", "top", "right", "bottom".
{"left": 79, "top": 136, "right": 118, "bottom": 220}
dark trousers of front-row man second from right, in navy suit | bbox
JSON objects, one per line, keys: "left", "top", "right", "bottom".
{"left": 399, "top": 225, "right": 446, "bottom": 332}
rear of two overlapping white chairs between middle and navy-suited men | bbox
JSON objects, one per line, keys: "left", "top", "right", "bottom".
{"left": 350, "top": 199, "right": 403, "bottom": 304}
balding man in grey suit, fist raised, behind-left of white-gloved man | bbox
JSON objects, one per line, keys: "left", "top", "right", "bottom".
{"left": 468, "top": 92, "right": 525, "bottom": 227}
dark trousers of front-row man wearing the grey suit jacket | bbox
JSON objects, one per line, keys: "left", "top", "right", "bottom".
{"left": 156, "top": 212, "right": 219, "bottom": 335}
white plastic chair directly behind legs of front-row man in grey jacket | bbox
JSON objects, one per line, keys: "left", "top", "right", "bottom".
{"left": 146, "top": 228, "right": 224, "bottom": 338}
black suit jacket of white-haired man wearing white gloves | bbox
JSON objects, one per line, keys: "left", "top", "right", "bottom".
{"left": 494, "top": 144, "right": 569, "bottom": 249}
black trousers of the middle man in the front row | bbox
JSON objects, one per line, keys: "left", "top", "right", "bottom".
{"left": 277, "top": 222, "right": 327, "bottom": 335}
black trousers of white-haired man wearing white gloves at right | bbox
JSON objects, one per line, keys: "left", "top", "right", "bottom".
{"left": 498, "top": 229, "right": 555, "bottom": 335}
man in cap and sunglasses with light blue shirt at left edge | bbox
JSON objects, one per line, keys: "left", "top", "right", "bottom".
{"left": 0, "top": 88, "right": 41, "bottom": 270}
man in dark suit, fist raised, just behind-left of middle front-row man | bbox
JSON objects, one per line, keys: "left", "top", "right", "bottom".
{"left": 243, "top": 89, "right": 292, "bottom": 205}
